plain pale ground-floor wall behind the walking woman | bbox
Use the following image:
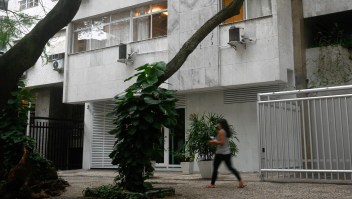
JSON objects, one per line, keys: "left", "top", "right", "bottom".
{"left": 186, "top": 91, "right": 259, "bottom": 171}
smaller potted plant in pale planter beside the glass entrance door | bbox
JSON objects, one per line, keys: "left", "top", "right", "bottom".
{"left": 174, "top": 143, "right": 194, "bottom": 174}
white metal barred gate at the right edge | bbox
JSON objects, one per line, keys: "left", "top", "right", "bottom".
{"left": 257, "top": 86, "right": 352, "bottom": 180}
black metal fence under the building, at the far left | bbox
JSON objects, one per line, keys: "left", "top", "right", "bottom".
{"left": 29, "top": 117, "right": 84, "bottom": 170}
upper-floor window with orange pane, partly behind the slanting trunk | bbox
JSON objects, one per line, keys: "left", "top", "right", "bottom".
{"left": 222, "top": 0, "right": 271, "bottom": 23}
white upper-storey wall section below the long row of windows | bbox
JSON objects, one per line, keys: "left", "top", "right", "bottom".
{"left": 64, "top": 37, "right": 167, "bottom": 103}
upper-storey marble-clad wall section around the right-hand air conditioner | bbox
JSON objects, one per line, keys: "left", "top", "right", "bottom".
{"left": 168, "top": 0, "right": 293, "bottom": 91}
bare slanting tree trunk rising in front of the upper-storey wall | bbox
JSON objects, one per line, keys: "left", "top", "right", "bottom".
{"left": 157, "top": 0, "right": 244, "bottom": 85}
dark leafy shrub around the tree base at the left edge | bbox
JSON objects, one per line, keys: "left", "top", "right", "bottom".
{"left": 0, "top": 81, "right": 59, "bottom": 198}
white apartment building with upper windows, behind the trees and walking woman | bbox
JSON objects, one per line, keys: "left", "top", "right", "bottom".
{"left": 9, "top": 0, "right": 352, "bottom": 171}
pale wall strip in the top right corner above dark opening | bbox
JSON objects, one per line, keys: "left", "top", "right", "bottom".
{"left": 303, "top": 0, "right": 352, "bottom": 18}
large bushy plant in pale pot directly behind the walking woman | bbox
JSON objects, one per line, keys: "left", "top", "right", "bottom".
{"left": 187, "top": 113, "right": 238, "bottom": 178}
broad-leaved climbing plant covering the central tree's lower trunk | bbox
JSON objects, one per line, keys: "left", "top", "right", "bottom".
{"left": 110, "top": 62, "right": 177, "bottom": 192}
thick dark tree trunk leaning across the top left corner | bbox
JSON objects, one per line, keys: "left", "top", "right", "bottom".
{"left": 0, "top": 0, "right": 81, "bottom": 110}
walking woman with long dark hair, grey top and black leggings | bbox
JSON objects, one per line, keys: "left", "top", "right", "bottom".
{"left": 207, "top": 119, "right": 245, "bottom": 188}
